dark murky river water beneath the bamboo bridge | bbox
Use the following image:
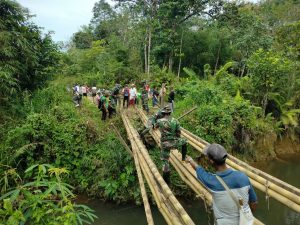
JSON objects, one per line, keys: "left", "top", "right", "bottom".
{"left": 80, "top": 155, "right": 300, "bottom": 225}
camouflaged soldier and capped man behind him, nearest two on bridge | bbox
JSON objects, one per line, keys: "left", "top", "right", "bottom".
{"left": 141, "top": 105, "right": 257, "bottom": 225}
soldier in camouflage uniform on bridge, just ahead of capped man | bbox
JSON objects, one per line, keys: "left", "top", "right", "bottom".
{"left": 155, "top": 105, "right": 187, "bottom": 184}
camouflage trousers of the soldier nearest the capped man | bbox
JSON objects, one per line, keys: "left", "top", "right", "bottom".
{"left": 161, "top": 138, "right": 187, "bottom": 173}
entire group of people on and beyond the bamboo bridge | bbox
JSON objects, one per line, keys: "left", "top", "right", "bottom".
{"left": 73, "top": 81, "right": 257, "bottom": 225}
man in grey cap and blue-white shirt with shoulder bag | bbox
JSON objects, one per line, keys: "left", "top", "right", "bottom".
{"left": 186, "top": 144, "right": 257, "bottom": 225}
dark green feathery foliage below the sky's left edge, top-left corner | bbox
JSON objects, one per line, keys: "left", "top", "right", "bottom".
{"left": 0, "top": 0, "right": 60, "bottom": 93}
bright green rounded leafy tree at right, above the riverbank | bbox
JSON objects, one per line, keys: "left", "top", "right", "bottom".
{"left": 248, "top": 49, "right": 295, "bottom": 118}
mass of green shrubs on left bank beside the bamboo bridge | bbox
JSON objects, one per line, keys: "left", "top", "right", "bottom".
{"left": 1, "top": 80, "right": 140, "bottom": 202}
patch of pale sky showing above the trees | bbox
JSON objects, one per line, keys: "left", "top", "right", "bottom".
{"left": 17, "top": 0, "right": 257, "bottom": 42}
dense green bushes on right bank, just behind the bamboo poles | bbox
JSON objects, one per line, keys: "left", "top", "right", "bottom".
{"left": 176, "top": 70, "right": 275, "bottom": 156}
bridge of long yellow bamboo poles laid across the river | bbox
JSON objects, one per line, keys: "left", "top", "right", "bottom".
{"left": 89, "top": 97, "right": 300, "bottom": 225}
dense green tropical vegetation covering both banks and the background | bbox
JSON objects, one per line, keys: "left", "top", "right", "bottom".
{"left": 0, "top": 0, "right": 300, "bottom": 224}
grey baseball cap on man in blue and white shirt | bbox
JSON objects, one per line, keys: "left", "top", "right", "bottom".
{"left": 203, "top": 143, "right": 227, "bottom": 164}
